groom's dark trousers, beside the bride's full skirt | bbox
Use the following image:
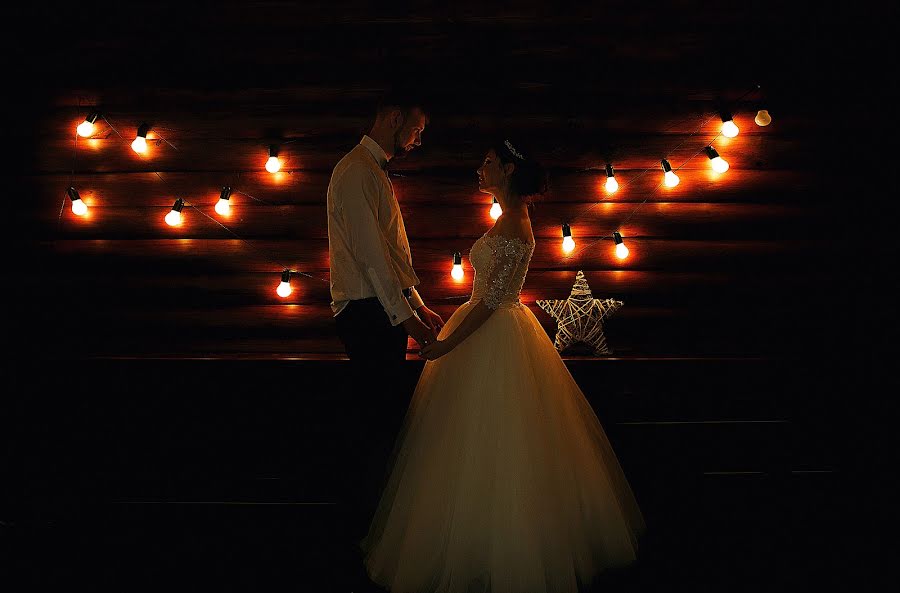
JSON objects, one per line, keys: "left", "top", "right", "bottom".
{"left": 335, "top": 298, "right": 411, "bottom": 539}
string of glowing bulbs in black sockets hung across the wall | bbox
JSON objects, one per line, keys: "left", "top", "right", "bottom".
{"left": 60, "top": 86, "right": 771, "bottom": 300}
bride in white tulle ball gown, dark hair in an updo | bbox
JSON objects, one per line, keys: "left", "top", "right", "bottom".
{"left": 361, "top": 140, "right": 644, "bottom": 593}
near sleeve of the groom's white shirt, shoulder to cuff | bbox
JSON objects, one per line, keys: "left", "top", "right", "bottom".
{"left": 335, "top": 166, "right": 421, "bottom": 325}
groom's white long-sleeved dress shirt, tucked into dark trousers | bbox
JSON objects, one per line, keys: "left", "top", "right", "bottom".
{"left": 327, "top": 136, "right": 422, "bottom": 325}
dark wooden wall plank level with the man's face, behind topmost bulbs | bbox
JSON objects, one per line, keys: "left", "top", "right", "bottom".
{"left": 36, "top": 106, "right": 804, "bottom": 138}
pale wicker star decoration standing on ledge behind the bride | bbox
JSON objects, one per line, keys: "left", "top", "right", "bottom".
{"left": 535, "top": 270, "right": 624, "bottom": 356}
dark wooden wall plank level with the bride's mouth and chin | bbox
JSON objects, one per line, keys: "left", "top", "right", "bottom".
{"left": 20, "top": 170, "right": 826, "bottom": 209}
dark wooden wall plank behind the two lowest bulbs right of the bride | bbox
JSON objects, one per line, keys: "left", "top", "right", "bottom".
{"left": 28, "top": 236, "right": 838, "bottom": 273}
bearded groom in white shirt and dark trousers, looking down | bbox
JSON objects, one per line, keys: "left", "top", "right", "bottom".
{"left": 327, "top": 85, "right": 444, "bottom": 552}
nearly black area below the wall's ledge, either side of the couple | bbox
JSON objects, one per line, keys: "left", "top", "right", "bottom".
{"left": 0, "top": 363, "right": 840, "bottom": 593}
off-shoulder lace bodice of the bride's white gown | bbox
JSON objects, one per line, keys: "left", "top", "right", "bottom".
{"left": 469, "top": 234, "right": 534, "bottom": 309}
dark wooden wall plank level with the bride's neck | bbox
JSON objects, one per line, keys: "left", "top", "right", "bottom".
{"left": 28, "top": 204, "right": 822, "bottom": 240}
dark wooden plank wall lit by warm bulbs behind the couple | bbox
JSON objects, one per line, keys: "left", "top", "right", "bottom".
{"left": 10, "top": 3, "right": 838, "bottom": 356}
